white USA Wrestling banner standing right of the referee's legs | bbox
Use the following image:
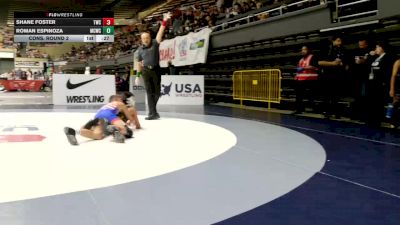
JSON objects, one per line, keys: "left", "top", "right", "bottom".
{"left": 158, "top": 75, "right": 204, "bottom": 105}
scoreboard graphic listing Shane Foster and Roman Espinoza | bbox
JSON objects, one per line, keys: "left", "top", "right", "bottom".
{"left": 14, "top": 11, "right": 114, "bottom": 42}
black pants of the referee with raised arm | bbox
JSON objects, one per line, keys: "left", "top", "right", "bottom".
{"left": 143, "top": 69, "right": 161, "bottom": 116}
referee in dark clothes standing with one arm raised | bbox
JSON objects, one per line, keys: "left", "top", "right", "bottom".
{"left": 136, "top": 13, "right": 171, "bottom": 120}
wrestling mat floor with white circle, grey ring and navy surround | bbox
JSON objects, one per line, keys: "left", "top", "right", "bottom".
{"left": 0, "top": 93, "right": 400, "bottom": 225}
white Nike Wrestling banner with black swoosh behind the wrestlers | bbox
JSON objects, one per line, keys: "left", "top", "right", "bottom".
{"left": 53, "top": 74, "right": 116, "bottom": 105}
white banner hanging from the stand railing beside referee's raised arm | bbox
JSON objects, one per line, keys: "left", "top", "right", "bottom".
{"left": 160, "top": 28, "right": 212, "bottom": 67}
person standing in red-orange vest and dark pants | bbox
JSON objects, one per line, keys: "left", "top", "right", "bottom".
{"left": 295, "top": 46, "right": 318, "bottom": 114}
